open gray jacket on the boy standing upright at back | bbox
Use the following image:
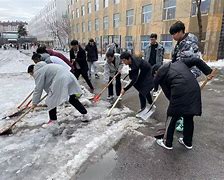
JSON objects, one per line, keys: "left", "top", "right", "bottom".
{"left": 144, "top": 44, "right": 164, "bottom": 66}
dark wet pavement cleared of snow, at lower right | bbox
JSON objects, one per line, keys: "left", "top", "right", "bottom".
{"left": 79, "top": 69, "right": 224, "bottom": 180}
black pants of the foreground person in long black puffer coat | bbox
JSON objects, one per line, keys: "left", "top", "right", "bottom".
{"left": 164, "top": 115, "right": 194, "bottom": 147}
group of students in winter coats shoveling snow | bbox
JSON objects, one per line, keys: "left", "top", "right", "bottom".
{"left": 28, "top": 21, "right": 212, "bottom": 149}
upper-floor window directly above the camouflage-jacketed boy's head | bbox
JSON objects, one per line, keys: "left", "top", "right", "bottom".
{"left": 163, "top": 0, "right": 176, "bottom": 20}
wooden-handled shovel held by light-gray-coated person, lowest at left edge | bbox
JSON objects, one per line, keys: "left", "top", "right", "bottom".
{"left": 0, "top": 94, "right": 47, "bottom": 135}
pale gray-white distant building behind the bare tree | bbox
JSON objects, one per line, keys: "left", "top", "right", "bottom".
{"left": 28, "top": 0, "right": 68, "bottom": 48}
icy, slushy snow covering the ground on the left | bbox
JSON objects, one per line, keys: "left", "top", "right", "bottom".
{"left": 0, "top": 50, "right": 140, "bottom": 180}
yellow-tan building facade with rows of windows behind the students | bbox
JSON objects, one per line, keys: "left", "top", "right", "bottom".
{"left": 69, "top": 0, "right": 224, "bottom": 60}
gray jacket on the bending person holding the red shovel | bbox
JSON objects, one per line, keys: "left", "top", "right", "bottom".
{"left": 104, "top": 54, "right": 123, "bottom": 81}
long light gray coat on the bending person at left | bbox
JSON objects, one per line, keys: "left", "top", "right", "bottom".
{"left": 33, "top": 61, "right": 82, "bottom": 109}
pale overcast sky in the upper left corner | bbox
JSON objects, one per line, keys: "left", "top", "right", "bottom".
{"left": 0, "top": 0, "right": 50, "bottom": 22}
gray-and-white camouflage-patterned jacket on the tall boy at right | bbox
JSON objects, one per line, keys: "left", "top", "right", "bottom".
{"left": 172, "top": 33, "right": 201, "bottom": 77}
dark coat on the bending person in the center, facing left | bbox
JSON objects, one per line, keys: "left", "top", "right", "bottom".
{"left": 124, "top": 58, "right": 153, "bottom": 96}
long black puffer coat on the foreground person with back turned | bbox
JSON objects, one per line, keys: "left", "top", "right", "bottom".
{"left": 154, "top": 58, "right": 212, "bottom": 116}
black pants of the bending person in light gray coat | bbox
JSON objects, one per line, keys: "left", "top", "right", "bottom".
{"left": 49, "top": 95, "right": 87, "bottom": 120}
